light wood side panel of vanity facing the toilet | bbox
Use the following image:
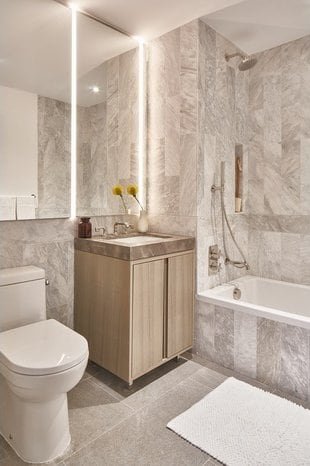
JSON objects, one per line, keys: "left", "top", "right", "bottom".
{"left": 75, "top": 251, "right": 130, "bottom": 380}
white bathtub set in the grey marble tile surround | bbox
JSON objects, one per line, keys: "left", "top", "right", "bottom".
{"left": 197, "top": 275, "right": 310, "bottom": 329}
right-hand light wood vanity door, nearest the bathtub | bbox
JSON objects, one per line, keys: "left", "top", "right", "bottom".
{"left": 167, "top": 253, "right": 194, "bottom": 358}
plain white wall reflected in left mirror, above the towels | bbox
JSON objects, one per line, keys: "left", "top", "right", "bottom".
{"left": 0, "top": 86, "right": 38, "bottom": 196}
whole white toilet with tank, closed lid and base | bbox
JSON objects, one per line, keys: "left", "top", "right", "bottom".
{"left": 0, "top": 266, "right": 88, "bottom": 463}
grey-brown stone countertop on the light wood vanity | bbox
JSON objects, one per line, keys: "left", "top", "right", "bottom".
{"left": 74, "top": 233, "right": 195, "bottom": 261}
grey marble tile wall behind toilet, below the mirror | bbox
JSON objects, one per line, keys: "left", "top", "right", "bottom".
{"left": 0, "top": 219, "right": 76, "bottom": 327}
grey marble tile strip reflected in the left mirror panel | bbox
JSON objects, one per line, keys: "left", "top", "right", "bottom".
{"left": 36, "top": 96, "right": 71, "bottom": 218}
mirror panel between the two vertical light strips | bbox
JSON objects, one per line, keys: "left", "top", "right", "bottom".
{"left": 77, "top": 14, "right": 139, "bottom": 216}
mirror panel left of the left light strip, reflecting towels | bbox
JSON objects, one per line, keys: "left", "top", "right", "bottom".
{"left": 0, "top": 0, "right": 71, "bottom": 220}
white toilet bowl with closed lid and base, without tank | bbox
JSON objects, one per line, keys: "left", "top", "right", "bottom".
{"left": 0, "top": 319, "right": 88, "bottom": 463}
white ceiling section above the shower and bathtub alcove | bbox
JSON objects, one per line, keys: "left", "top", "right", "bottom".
{"left": 202, "top": 0, "right": 310, "bottom": 54}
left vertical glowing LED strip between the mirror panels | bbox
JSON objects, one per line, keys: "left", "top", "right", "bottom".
{"left": 70, "top": 4, "right": 77, "bottom": 219}
